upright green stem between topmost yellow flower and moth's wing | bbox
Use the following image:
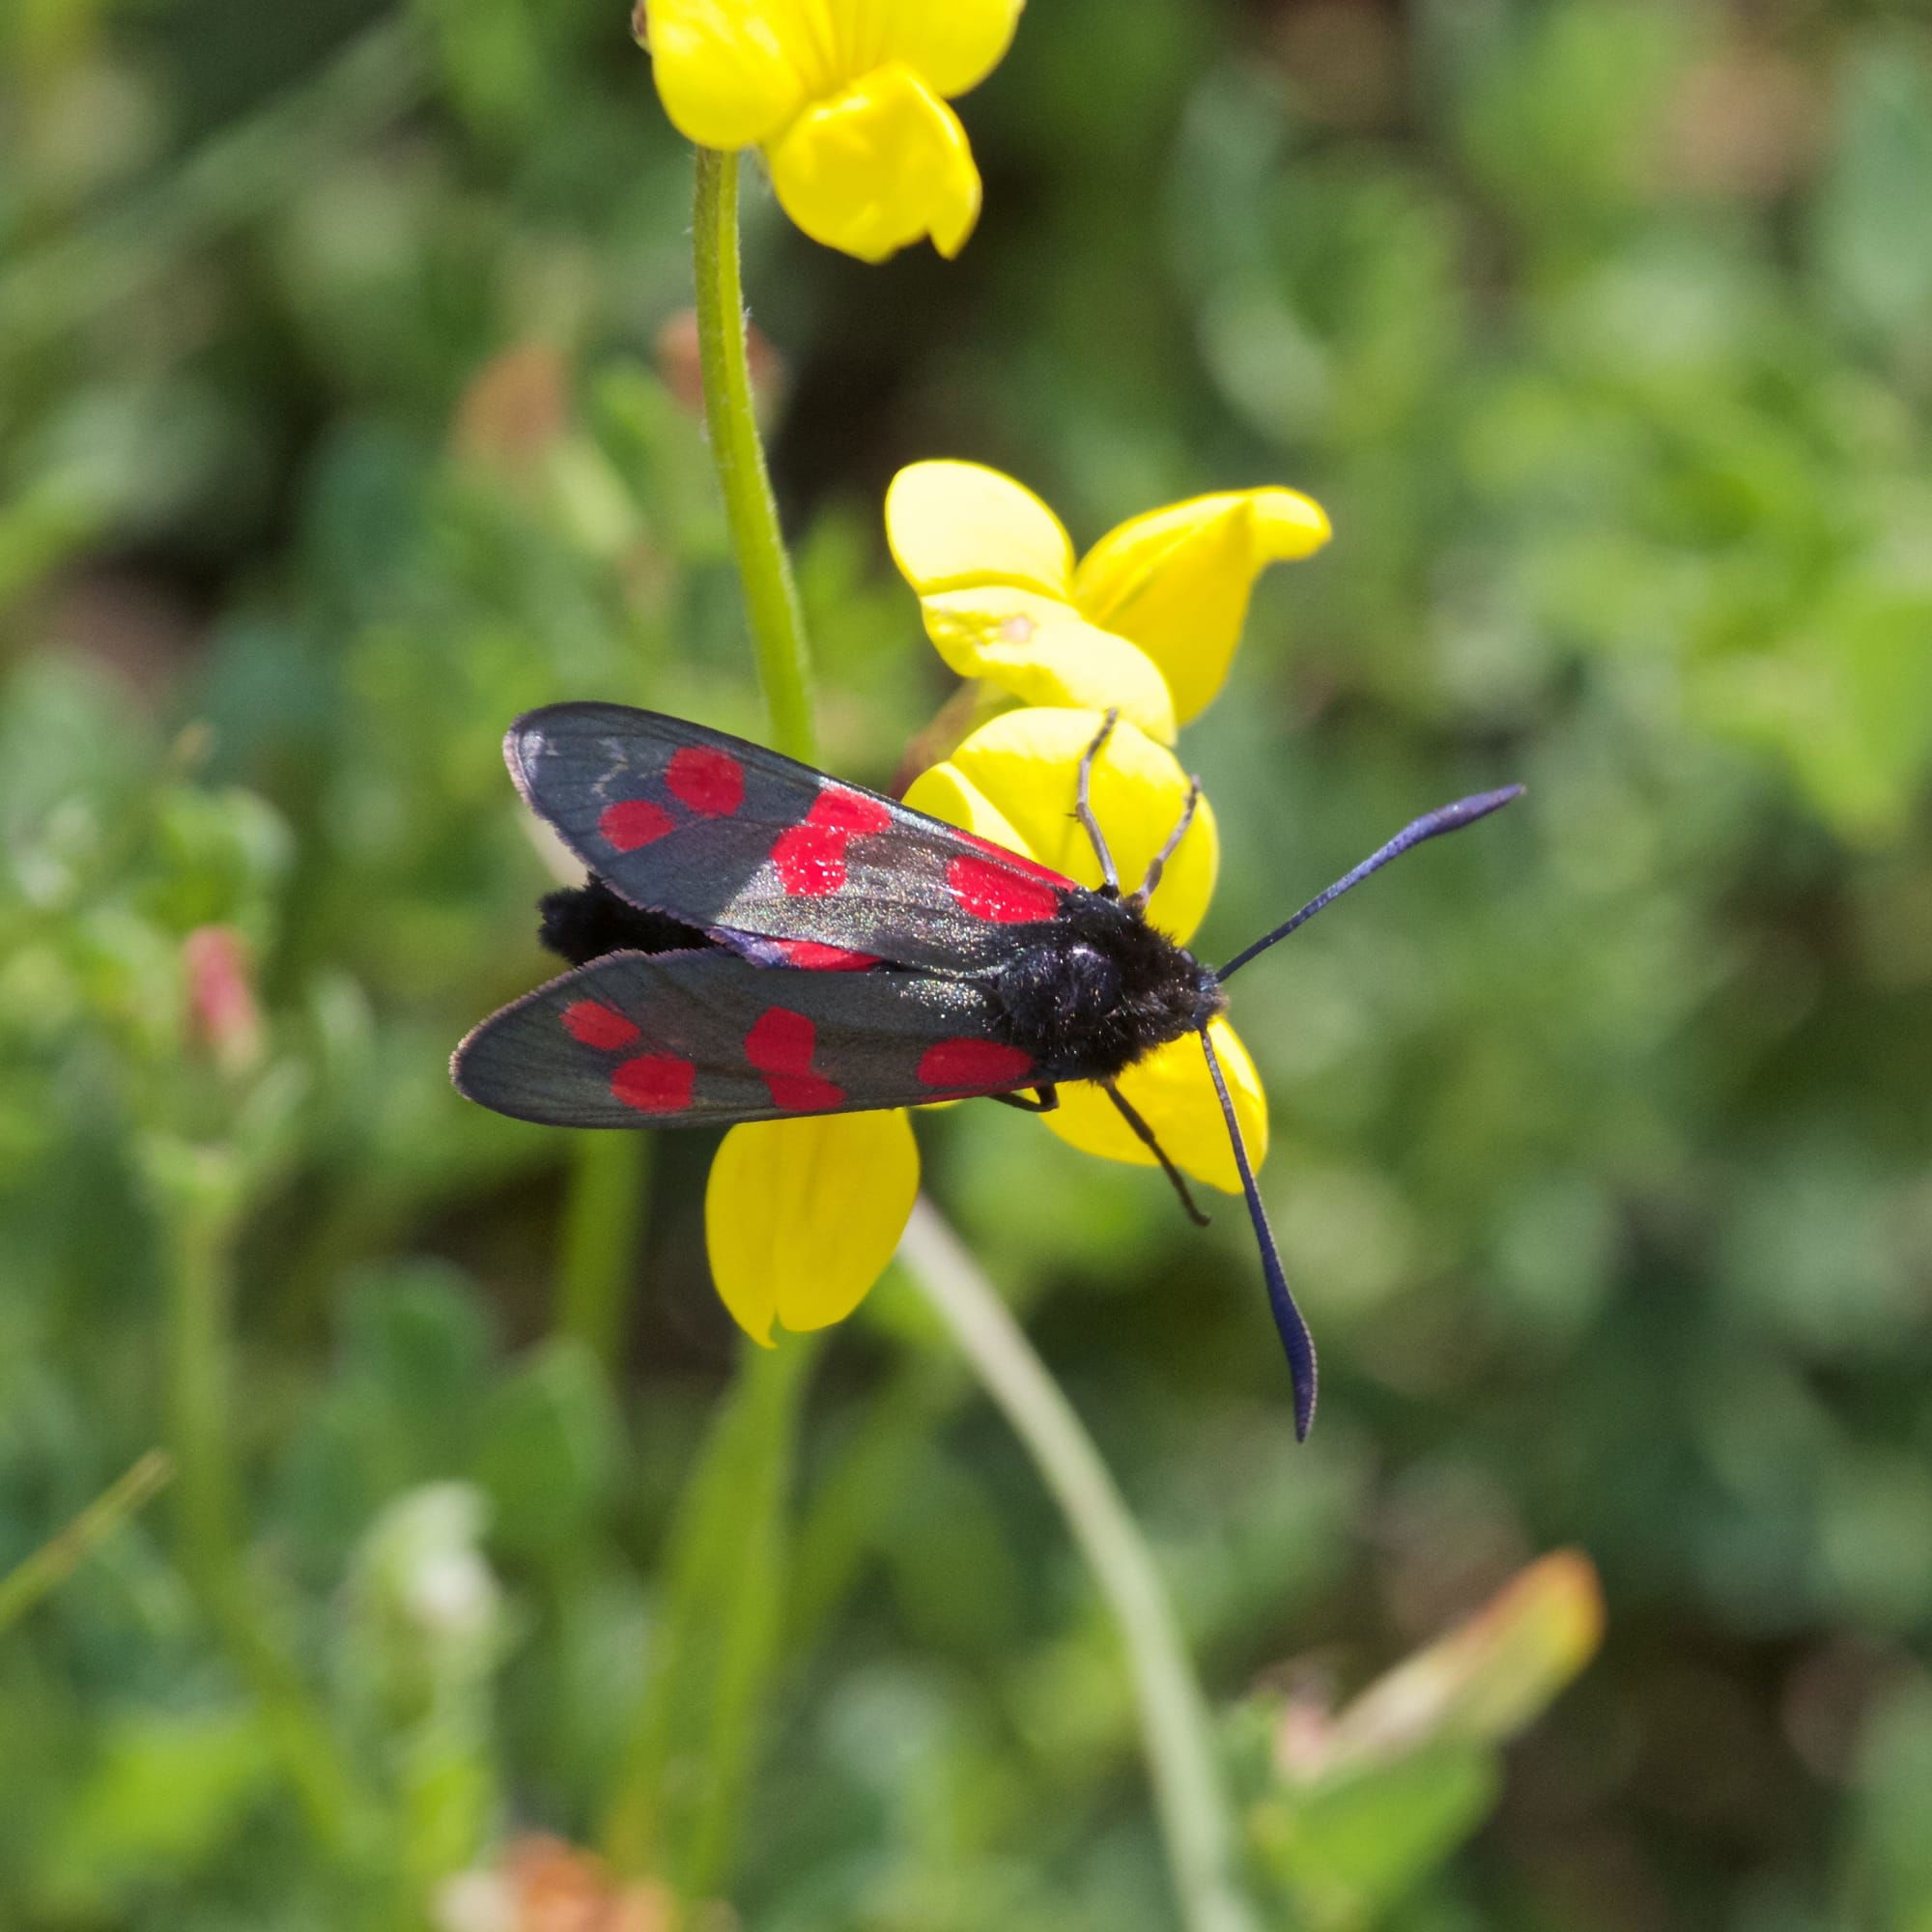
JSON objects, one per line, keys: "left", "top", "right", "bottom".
{"left": 692, "top": 147, "right": 817, "bottom": 765}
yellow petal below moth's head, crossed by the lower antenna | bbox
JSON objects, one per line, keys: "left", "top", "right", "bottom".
{"left": 1041, "top": 1020, "right": 1267, "bottom": 1194}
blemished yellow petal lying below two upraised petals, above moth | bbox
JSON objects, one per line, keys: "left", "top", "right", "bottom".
{"left": 920, "top": 583, "right": 1175, "bottom": 744}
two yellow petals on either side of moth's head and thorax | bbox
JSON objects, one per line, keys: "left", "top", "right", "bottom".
{"left": 906, "top": 709, "right": 1267, "bottom": 1194}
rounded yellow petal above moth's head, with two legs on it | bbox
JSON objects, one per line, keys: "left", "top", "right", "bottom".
{"left": 906, "top": 709, "right": 1221, "bottom": 945}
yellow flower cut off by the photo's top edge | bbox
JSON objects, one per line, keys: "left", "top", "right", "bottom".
{"left": 647, "top": 0, "right": 1024, "bottom": 261}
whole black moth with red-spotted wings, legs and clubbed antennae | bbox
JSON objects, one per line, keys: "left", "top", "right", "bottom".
{"left": 450, "top": 703, "right": 1520, "bottom": 1435}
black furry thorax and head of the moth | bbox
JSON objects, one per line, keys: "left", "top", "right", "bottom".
{"left": 991, "top": 893, "right": 1227, "bottom": 1080}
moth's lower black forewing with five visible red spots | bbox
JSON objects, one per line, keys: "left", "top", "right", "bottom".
{"left": 450, "top": 949, "right": 1036, "bottom": 1126}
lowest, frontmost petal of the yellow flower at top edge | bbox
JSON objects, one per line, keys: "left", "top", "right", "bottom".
{"left": 767, "top": 62, "right": 980, "bottom": 261}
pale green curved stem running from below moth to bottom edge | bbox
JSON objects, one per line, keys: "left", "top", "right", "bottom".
{"left": 898, "top": 1198, "right": 1256, "bottom": 1932}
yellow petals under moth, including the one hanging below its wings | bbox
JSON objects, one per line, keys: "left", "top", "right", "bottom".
{"left": 705, "top": 709, "right": 1267, "bottom": 1347}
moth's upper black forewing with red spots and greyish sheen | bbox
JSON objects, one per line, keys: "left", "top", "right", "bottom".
{"left": 504, "top": 703, "right": 1084, "bottom": 972}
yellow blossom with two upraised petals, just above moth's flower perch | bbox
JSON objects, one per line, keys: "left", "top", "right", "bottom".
{"left": 885, "top": 462, "right": 1329, "bottom": 744}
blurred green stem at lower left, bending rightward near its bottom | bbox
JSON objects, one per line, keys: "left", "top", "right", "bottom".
{"left": 160, "top": 1150, "right": 379, "bottom": 1874}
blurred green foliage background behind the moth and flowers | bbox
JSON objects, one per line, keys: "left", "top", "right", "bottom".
{"left": 0, "top": 0, "right": 1932, "bottom": 1932}
